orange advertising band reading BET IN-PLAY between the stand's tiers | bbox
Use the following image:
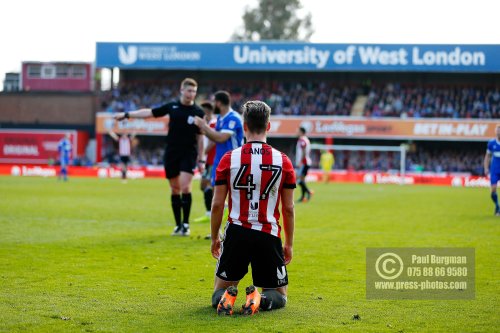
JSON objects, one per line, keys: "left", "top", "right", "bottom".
{"left": 96, "top": 113, "right": 500, "bottom": 141}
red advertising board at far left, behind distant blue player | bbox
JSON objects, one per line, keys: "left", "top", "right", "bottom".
{"left": 0, "top": 129, "right": 88, "bottom": 164}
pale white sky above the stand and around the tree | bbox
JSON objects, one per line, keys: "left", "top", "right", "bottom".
{"left": 0, "top": 0, "right": 500, "bottom": 90}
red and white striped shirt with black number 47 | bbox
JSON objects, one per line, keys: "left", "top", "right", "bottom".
{"left": 215, "top": 141, "right": 295, "bottom": 237}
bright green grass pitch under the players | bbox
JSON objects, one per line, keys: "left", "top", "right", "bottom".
{"left": 0, "top": 177, "right": 500, "bottom": 332}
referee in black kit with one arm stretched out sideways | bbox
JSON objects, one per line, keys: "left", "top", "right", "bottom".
{"left": 114, "top": 78, "right": 205, "bottom": 236}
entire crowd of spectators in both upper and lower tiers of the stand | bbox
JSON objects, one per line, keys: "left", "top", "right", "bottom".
{"left": 101, "top": 81, "right": 488, "bottom": 174}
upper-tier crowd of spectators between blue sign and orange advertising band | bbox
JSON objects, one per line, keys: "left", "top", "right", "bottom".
{"left": 101, "top": 81, "right": 500, "bottom": 119}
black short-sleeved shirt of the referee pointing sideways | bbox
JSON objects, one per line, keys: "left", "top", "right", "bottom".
{"left": 152, "top": 101, "right": 205, "bottom": 149}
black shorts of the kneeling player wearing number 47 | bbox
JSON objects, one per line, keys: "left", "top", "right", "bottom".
{"left": 215, "top": 223, "right": 288, "bottom": 289}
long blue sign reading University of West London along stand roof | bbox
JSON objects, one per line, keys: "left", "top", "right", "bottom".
{"left": 96, "top": 43, "right": 500, "bottom": 73}
